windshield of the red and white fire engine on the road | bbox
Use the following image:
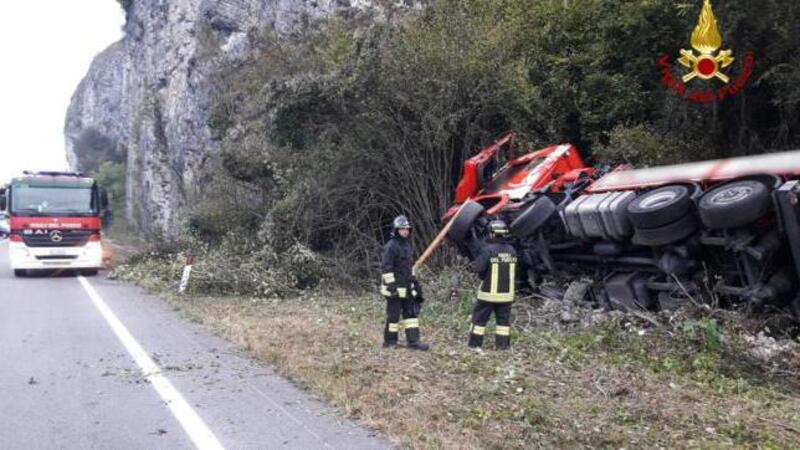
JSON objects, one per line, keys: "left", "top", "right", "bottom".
{"left": 10, "top": 185, "right": 97, "bottom": 216}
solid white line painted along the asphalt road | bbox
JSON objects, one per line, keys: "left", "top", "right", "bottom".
{"left": 78, "top": 277, "right": 224, "bottom": 450}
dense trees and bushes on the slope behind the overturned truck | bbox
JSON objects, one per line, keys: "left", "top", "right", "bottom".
{"left": 193, "top": 0, "right": 800, "bottom": 292}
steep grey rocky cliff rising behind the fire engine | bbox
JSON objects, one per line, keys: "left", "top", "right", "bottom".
{"left": 65, "top": 0, "right": 403, "bottom": 236}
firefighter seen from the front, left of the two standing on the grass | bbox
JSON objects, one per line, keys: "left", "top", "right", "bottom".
{"left": 381, "top": 216, "right": 429, "bottom": 350}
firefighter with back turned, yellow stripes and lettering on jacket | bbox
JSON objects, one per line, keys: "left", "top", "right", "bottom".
{"left": 469, "top": 220, "right": 517, "bottom": 350}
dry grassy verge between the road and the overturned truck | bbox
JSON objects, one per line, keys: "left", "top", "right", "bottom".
{"left": 164, "top": 295, "right": 800, "bottom": 448}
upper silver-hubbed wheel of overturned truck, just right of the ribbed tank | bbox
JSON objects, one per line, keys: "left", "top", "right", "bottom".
{"left": 628, "top": 185, "right": 692, "bottom": 229}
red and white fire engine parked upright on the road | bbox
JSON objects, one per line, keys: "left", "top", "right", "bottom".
{"left": 0, "top": 171, "right": 108, "bottom": 276}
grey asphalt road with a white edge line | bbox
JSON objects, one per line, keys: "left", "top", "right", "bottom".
{"left": 0, "top": 242, "right": 390, "bottom": 449}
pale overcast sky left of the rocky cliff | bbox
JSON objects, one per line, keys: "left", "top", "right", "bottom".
{"left": 0, "top": 0, "right": 125, "bottom": 185}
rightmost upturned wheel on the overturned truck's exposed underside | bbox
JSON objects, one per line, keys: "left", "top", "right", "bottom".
{"left": 698, "top": 180, "right": 771, "bottom": 230}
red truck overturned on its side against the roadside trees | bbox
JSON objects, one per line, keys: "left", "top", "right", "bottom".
{"left": 443, "top": 134, "right": 800, "bottom": 315}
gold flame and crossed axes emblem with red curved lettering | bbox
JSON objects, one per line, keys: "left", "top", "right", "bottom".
{"left": 658, "top": 0, "right": 755, "bottom": 103}
